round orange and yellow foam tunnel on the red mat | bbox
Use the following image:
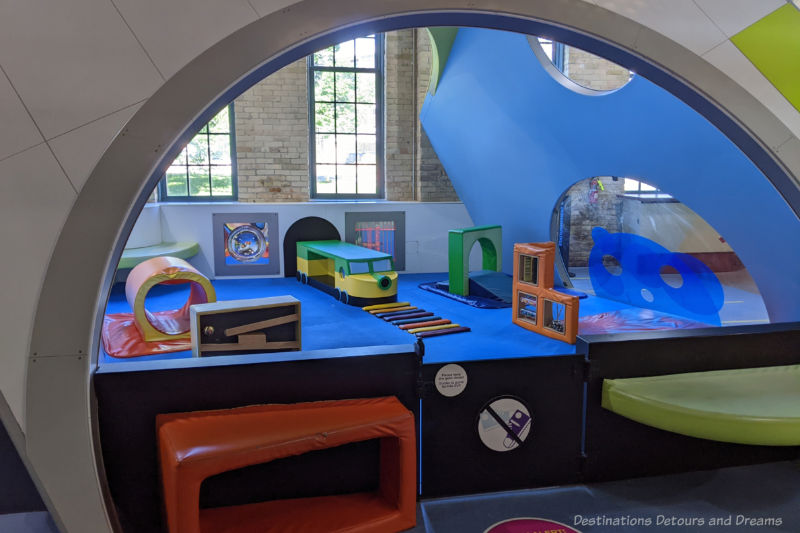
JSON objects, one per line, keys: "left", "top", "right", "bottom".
{"left": 125, "top": 257, "right": 217, "bottom": 342}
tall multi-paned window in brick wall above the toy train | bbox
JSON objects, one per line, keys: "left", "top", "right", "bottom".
{"left": 308, "top": 34, "right": 384, "bottom": 199}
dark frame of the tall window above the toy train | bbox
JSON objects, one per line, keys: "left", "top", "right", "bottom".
{"left": 306, "top": 33, "right": 386, "bottom": 200}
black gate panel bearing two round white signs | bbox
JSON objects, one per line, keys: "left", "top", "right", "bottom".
{"left": 421, "top": 355, "right": 583, "bottom": 498}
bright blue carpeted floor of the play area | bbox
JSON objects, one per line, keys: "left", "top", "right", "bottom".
{"left": 100, "top": 273, "right": 652, "bottom": 364}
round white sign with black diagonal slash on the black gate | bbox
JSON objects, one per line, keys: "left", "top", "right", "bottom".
{"left": 478, "top": 398, "right": 532, "bottom": 452}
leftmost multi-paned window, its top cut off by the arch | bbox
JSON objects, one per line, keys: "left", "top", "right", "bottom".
{"left": 159, "top": 104, "right": 237, "bottom": 202}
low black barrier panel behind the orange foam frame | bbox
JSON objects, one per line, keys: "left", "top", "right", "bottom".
{"left": 93, "top": 345, "right": 420, "bottom": 533}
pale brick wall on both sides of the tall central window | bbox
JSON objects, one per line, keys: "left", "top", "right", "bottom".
{"left": 234, "top": 29, "right": 458, "bottom": 202}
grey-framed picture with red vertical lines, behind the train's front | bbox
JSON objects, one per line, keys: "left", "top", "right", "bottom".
{"left": 344, "top": 211, "right": 406, "bottom": 270}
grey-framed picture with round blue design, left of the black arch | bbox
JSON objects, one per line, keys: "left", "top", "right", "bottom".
{"left": 212, "top": 213, "right": 281, "bottom": 276}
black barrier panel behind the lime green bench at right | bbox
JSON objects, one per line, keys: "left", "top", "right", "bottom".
{"left": 582, "top": 323, "right": 800, "bottom": 481}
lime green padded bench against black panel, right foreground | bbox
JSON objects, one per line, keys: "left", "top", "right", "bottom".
{"left": 602, "top": 365, "right": 800, "bottom": 446}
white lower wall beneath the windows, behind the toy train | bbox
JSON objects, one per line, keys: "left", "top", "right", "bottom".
{"left": 159, "top": 202, "right": 473, "bottom": 278}
